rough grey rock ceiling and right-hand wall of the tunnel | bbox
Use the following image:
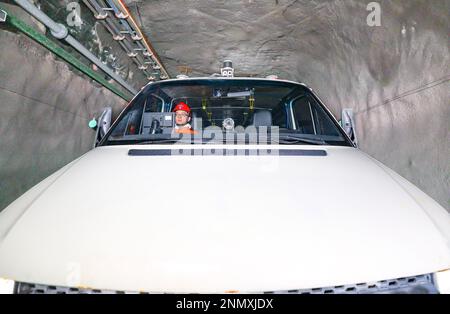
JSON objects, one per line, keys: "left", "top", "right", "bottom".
{"left": 127, "top": 0, "right": 450, "bottom": 210}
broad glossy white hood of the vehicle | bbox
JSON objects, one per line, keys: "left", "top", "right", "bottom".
{"left": 0, "top": 145, "right": 450, "bottom": 292}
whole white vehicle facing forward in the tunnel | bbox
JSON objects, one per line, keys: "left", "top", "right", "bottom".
{"left": 0, "top": 77, "right": 450, "bottom": 293}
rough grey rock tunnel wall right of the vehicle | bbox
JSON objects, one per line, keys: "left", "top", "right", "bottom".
{"left": 294, "top": 0, "right": 450, "bottom": 211}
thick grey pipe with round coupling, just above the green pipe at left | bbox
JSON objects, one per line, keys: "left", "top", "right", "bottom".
{"left": 14, "top": 0, "right": 137, "bottom": 95}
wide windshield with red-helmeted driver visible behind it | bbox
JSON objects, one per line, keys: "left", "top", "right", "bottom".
{"left": 100, "top": 79, "right": 352, "bottom": 146}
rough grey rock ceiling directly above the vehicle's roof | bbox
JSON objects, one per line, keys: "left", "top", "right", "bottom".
{"left": 127, "top": 0, "right": 336, "bottom": 78}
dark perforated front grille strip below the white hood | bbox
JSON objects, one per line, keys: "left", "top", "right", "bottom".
{"left": 15, "top": 274, "right": 438, "bottom": 294}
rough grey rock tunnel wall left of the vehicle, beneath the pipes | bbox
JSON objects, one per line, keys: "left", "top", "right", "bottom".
{"left": 0, "top": 5, "right": 125, "bottom": 210}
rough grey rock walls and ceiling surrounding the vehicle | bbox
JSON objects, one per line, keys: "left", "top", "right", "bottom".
{"left": 0, "top": 0, "right": 450, "bottom": 210}
